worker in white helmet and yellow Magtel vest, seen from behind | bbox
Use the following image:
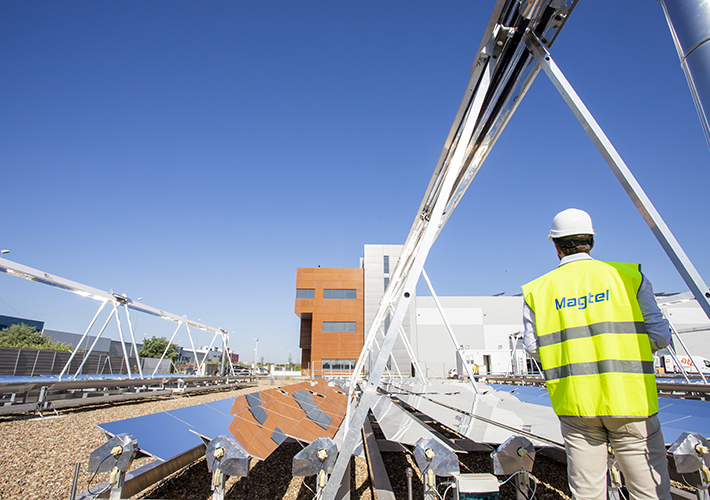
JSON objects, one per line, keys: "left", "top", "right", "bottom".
{"left": 522, "top": 208, "right": 670, "bottom": 500}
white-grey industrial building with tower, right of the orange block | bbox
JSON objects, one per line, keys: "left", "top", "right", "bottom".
{"left": 360, "top": 245, "right": 710, "bottom": 378}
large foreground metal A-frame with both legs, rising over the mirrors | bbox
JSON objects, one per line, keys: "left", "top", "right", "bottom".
{"left": 332, "top": 7, "right": 710, "bottom": 500}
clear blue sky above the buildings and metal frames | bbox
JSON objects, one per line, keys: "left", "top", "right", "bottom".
{"left": 0, "top": 0, "right": 710, "bottom": 361}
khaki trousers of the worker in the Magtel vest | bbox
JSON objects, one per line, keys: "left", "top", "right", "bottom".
{"left": 560, "top": 415, "right": 671, "bottom": 500}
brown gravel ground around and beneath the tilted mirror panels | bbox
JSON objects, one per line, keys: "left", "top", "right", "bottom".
{"left": 0, "top": 380, "right": 569, "bottom": 500}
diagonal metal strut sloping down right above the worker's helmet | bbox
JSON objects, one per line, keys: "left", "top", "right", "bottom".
{"left": 524, "top": 31, "right": 710, "bottom": 318}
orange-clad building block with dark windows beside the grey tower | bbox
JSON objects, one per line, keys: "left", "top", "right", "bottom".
{"left": 295, "top": 268, "right": 364, "bottom": 376}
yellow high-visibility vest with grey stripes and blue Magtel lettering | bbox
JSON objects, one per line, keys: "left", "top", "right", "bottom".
{"left": 522, "top": 259, "right": 658, "bottom": 417}
